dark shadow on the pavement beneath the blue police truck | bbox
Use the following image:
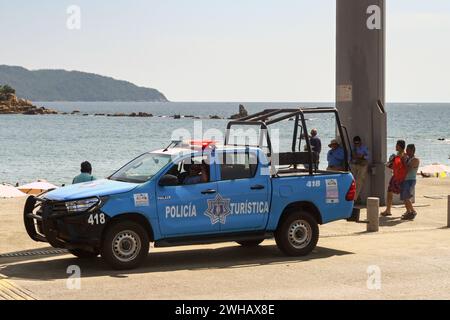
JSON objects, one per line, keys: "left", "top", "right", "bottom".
{"left": 0, "top": 245, "right": 353, "bottom": 281}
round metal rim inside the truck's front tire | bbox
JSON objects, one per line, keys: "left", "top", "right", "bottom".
{"left": 112, "top": 230, "right": 141, "bottom": 262}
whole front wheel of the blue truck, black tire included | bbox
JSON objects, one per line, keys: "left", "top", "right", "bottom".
{"left": 101, "top": 221, "right": 150, "bottom": 270}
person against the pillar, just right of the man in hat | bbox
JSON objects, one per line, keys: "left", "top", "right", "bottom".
{"left": 351, "top": 136, "right": 369, "bottom": 201}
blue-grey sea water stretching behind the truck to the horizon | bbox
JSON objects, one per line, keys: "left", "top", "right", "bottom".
{"left": 0, "top": 102, "right": 450, "bottom": 185}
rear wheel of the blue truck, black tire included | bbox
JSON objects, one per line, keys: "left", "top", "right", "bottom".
{"left": 275, "top": 211, "right": 319, "bottom": 257}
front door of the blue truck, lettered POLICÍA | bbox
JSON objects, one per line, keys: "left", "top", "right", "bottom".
{"left": 156, "top": 155, "right": 220, "bottom": 238}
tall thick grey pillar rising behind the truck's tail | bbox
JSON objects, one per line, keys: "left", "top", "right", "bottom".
{"left": 336, "top": 0, "right": 388, "bottom": 205}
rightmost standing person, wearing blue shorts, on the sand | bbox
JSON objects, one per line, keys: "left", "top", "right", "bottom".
{"left": 400, "top": 144, "right": 420, "bottom": 220}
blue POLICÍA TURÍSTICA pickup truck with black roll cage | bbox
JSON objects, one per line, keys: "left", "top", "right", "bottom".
{"left": 24, "top": 108, "right": 355, "bottom": 270}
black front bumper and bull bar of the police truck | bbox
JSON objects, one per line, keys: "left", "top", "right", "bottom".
{"left": 23, "top": 196, "right": 110, "bottom": 251}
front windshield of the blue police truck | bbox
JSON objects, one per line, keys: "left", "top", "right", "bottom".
{"left": 110, "top": 153, "right": 171, "bottom": 183}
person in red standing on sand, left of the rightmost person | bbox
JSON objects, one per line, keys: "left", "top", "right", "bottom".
{"left": 381, "top": 140, "right": 408, "bottom": 217}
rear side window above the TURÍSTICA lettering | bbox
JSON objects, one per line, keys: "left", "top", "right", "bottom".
{"left": 220, "top": 152, "right": 258, "bottom": 181}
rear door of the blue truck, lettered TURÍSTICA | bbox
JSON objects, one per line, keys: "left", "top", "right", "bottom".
{"left": 217, "top": 150, "right": 270, "bottom": 232}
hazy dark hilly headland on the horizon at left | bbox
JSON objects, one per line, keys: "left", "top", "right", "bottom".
{"left": 0, "top": 65, "right": 168, "bottom": 102}
